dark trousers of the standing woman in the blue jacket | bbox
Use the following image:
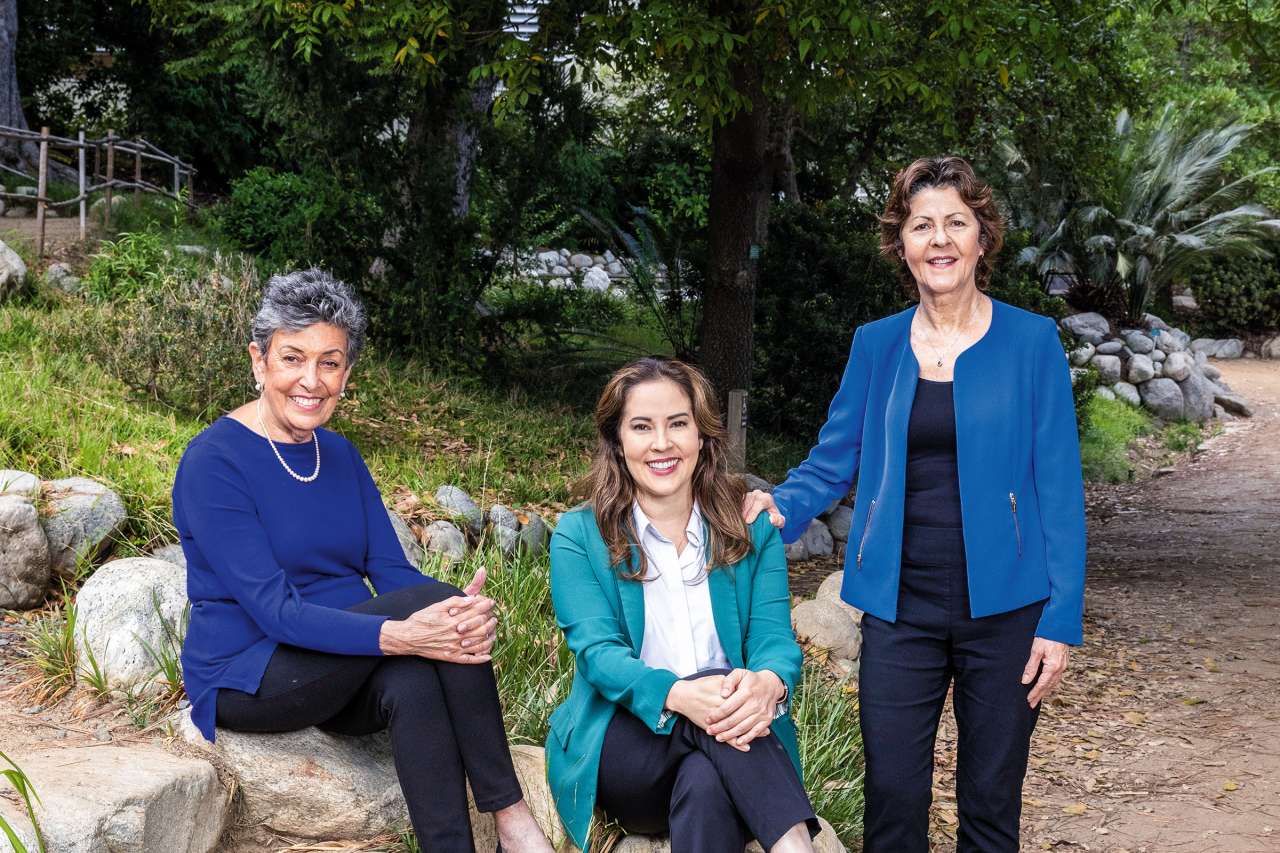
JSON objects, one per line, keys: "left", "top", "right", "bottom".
{"left": 859, "top": 525, "right": 1044, "bottom": 853}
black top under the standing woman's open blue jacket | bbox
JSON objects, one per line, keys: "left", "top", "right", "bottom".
{"left": 904, "top": 378, "right": 961, "bottom": 528}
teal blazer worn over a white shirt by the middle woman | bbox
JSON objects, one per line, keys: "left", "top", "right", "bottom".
{"left": 547, "top": 506, "right": 801, "bottom": 850}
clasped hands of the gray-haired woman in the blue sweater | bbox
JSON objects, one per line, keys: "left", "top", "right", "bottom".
{"left": 379, "top": 569, "right": 498, "bottom": 663}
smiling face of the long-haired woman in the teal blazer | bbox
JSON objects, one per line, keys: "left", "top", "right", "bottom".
{"left": 618, "top": 379, "right": 703, "bottom": 508}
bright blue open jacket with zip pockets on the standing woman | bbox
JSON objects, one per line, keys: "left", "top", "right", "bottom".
{"left": 773, "top": 300, "right": 1084, "bottom": 644}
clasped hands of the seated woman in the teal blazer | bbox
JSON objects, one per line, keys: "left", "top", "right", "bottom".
{"left": 667, "top": 670, "right": 783, "bottom": 752}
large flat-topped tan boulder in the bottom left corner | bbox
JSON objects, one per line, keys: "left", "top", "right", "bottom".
{"left": 0, "top": 745, "right": 230, "bottom": 853}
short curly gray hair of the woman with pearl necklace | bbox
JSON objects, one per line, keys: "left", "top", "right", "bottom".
{"left": 253, "top": 269, "right": 369, "bottom": 364}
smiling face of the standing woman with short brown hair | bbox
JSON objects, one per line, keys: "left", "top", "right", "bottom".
{"left": 901, "top": 187, "right": 982, "bottom": 296}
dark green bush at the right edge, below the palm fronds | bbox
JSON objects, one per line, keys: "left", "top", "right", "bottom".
{"left": 1193, "top": 257, "right": 1280, "bottom": 337}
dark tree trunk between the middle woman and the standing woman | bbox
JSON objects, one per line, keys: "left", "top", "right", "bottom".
{"left": 700, "top": 59, "right": 773, "bottom": 401}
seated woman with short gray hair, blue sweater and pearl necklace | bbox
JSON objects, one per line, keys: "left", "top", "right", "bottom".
{"left": 173, "top": 270, "right": 552, "bottom": 853}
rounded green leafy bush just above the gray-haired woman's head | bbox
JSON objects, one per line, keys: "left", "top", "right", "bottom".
{"left": 215, "top": 167, "right": 381, "bottom": 282}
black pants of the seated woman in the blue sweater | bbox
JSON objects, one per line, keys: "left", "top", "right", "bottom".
{"left": 218, "top": 580, "right": 524, "bottom": 853}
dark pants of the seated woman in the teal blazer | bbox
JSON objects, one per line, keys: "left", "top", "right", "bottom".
{"left": 596, "top": 670, "right": 818, "bottom": 853}
